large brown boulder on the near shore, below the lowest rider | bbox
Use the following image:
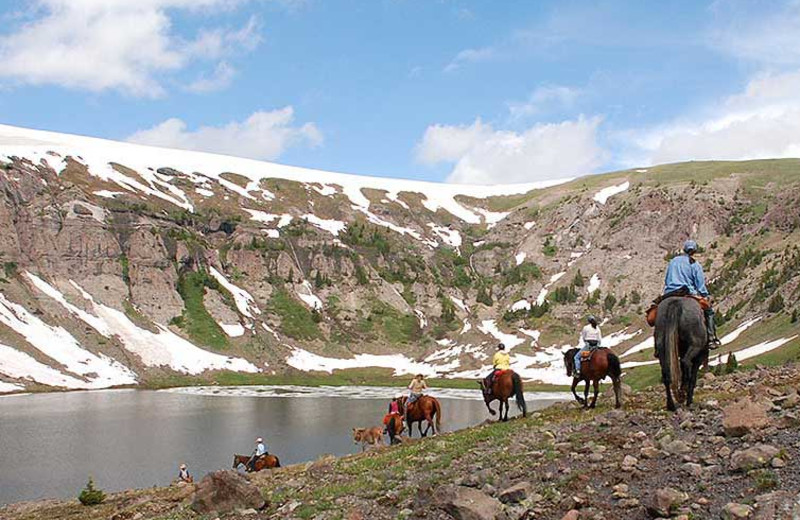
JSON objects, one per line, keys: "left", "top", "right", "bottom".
{"left": 192, "top": 470, "right": 266, "bottom": 514}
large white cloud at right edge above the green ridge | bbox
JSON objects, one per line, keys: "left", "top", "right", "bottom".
{"left": 624, "top": 71, "right": 800, "bottom": 164}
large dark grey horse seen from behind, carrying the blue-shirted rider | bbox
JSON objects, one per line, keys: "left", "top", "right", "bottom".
{"left": 655, "top": 297, "right": 708, "bottom": 412}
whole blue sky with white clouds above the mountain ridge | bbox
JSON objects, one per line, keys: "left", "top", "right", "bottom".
{"left": 0, "top": 0, "right": 800, "bottom": 184}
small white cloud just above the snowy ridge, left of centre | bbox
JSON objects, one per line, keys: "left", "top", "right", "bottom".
{"left": 128, "top": 106, "right": 323, "bottom": 160}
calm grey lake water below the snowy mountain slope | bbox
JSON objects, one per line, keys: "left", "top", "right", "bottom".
{"left": 0, "top": 387, "right": 563, "bottom": 504}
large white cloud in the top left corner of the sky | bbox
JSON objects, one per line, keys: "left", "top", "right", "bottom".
{"left": 0, "top": 0, "right": 259, "bottom": 97}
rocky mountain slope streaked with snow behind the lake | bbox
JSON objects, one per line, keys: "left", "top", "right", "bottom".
{"left": 0, "top": 126, "right": 800, "bottom": 391}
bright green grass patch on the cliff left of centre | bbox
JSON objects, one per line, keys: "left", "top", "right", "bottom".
{"left": 173, "top": 271, "right": 228, "bottom": 350}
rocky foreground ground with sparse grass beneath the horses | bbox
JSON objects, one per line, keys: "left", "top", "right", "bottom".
{"left": 0, "top": 365, "right": 800, "bottom": 520}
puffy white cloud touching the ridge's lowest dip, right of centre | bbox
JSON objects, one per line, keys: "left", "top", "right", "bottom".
{"left": 416, "top": 117, "right": 605, "bottom": 184}
